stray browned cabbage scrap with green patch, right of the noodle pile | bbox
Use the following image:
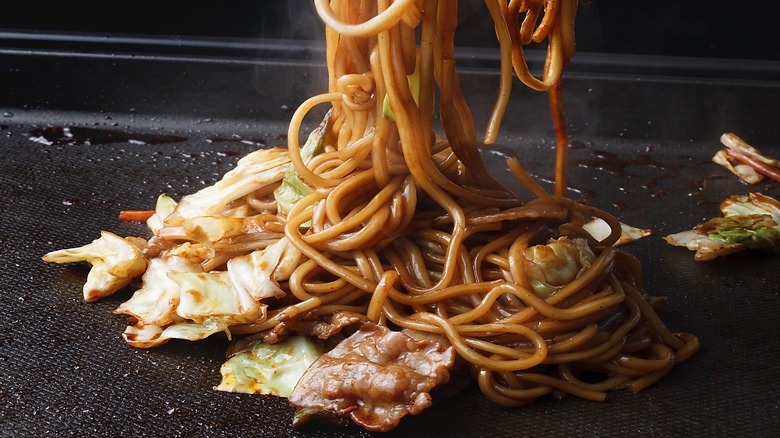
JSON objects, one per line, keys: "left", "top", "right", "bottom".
{"left": 664, "top": 193, "right": 780, "bottom": 261}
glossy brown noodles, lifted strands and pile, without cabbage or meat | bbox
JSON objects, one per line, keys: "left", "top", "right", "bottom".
{"left": 276, "top": 0, "right": 698, "bottom": 406}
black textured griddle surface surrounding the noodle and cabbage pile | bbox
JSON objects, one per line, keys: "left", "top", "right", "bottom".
{"left": 0, "top": 38, "right": 780, "bottom": 437}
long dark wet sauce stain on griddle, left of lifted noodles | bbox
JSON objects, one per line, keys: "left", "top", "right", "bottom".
{"left": 29, "top": 126, "right": 187, "bottom": 146}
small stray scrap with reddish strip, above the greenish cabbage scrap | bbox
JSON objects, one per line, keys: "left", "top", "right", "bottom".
{"left": 712, "top": 132, "right": 780, "bottom": 184}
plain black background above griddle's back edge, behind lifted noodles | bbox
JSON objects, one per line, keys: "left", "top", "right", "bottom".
{"left": 0, "top": 0, "right": 780, "bottom": 60}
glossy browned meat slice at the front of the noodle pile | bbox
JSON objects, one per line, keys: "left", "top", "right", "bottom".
{"left": 289, "top": 323, "right": 455, "bottom": 432}
